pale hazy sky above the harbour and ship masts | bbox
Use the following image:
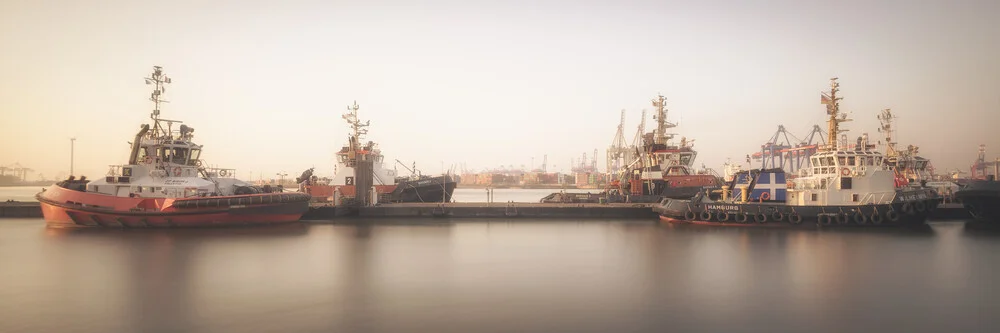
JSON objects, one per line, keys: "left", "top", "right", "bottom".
{"left": 0, "top": 0, "right": 1000, "bottom": 182}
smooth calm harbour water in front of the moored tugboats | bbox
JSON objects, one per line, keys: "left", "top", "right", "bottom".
{"left": 0, "top": 219, "right": 1000, "bottom": 332}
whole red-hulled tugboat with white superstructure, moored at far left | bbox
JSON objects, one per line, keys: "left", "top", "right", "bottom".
{"left": 35, "top": 66, "right": 309, "bottom": 227}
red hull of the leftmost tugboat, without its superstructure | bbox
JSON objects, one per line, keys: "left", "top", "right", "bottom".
{"left": 36, "top": 186, "right": 309, "bottom": 228}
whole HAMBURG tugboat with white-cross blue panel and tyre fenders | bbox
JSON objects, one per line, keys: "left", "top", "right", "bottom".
{"left": 656, "top": 78, "right": 941, "bottom": 226}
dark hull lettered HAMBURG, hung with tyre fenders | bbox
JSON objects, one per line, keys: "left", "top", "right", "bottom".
{"left": 654, "top": 191, "right": 941, "bottom": 227}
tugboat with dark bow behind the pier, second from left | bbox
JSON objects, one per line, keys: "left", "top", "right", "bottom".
{"left": 296, "top": 102, "right": 458, "bottom": 204}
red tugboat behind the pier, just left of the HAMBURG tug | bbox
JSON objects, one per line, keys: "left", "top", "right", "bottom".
{"left": 540, "top": 95, "right": 721, "bottom": 203}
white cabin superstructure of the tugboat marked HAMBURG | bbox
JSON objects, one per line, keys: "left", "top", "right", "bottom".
{"left": 786, "top": 149, "right": 896, "bottom": 206}
